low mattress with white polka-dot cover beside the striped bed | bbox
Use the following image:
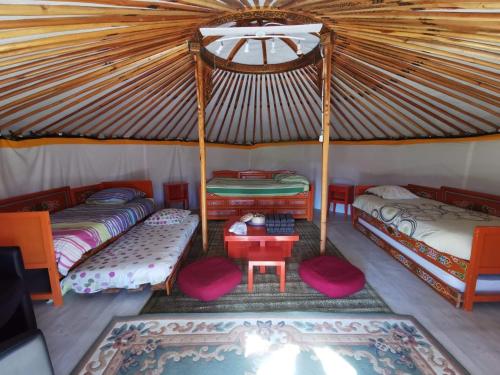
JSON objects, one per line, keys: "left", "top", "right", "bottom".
{"left": 61, "top": 215, "right": 199, "bottom": 293}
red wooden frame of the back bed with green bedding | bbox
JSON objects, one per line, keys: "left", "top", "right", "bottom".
{"left": 207, "top": 170, "right": 314, "bottom": 221}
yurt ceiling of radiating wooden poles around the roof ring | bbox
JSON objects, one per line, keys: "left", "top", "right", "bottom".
{"left": 0, "top": 0, "right": 500, "bottom": 144}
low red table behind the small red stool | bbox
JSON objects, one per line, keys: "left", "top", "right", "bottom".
{"left": 224, "top": 217, "right": 299, "bottom": 259}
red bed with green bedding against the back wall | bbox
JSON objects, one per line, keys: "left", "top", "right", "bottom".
{"left": 203, "top": 170, "right": 314, "bottom": 221}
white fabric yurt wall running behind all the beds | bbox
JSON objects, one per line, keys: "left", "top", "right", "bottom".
{"left": 0, "top": 141, "right": 500, "bottom": 207}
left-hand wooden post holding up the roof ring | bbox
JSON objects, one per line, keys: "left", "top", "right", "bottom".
{"left": 189, "top": 42, "right": 208, "bottom": 252}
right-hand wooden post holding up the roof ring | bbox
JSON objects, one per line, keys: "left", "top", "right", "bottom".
{"left": 320, "top": 33, "right": 333, "bottom": 254}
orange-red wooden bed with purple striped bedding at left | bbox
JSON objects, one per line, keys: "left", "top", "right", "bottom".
{"left": 0, "top": 181, "right": 154, "bottom": 306}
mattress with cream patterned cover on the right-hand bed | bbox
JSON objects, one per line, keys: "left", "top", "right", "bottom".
{"left": 353, "top": 194, "right": 500, "bottom": 260}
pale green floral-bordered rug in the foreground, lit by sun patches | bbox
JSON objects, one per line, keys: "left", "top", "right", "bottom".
{"left": 74, "top": 312, "right": 467, "bottom": 375}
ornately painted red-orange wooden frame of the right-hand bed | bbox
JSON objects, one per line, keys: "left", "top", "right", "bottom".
{"left": 352, "top": 185, "right": 500, "bottom": 311}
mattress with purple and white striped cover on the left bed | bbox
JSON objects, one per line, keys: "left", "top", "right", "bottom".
{"left": 50, "top": 198, "right": 155, "bottom": 276}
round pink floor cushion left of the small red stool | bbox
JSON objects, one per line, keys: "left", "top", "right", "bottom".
{"left": 177, "top": 257, "right": 242, "bottom": 301}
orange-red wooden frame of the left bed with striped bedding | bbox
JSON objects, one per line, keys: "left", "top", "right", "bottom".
{"left": 0, "top": 180, "right": 153, "bottom": 306}
